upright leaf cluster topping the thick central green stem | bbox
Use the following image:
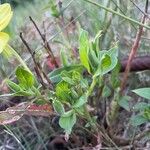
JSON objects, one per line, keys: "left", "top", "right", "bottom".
{"left": 79, "top": 29, "right": 118, "bottom": 77}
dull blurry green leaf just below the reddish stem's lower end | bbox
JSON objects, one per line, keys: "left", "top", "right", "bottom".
{"left": 118, "top": 96, "right": 131, "bottom": 111}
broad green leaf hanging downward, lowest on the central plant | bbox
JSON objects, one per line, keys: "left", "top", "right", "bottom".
{"left": 59, "top": 110, "right": 76, "bottom": 134}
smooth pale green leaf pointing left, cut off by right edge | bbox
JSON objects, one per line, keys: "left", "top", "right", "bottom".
{"left": 132, "top": 88, "right": 150, "bottom": 100}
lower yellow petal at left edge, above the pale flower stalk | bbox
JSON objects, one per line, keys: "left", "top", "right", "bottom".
{"left": 0, "top": 32, "right": 9, "bottom": 53}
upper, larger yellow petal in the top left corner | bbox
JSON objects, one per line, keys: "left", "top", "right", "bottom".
{"left": 0, "top": 3, "right": 13, "bottom": 31}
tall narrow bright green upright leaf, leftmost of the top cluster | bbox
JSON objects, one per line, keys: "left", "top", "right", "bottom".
{"left": 79, "top": 29, "right": 90, "bottom": 73}
